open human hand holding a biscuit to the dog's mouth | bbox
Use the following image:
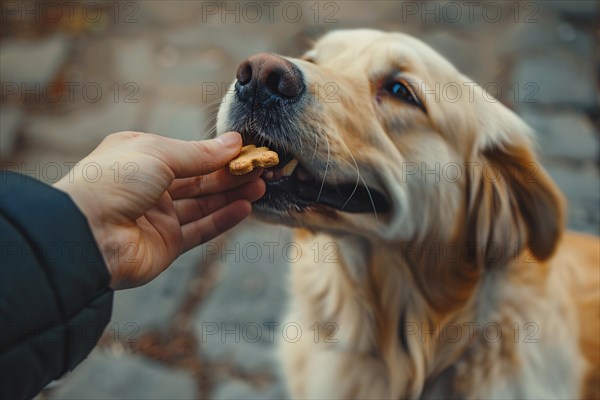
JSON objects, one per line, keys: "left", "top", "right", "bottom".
{"left": 54, "top": 132, "right": 265, "bottom": 289}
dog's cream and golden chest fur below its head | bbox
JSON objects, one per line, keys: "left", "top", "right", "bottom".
{"left": 282, "top": 231, "right": 587, "bottom": 398}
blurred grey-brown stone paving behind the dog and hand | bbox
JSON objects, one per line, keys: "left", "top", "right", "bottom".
{"left": 0, "top": 0, "right": 600, "bottom": 399}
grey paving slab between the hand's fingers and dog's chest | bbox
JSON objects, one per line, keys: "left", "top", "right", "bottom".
{"left": 195, "top": 221, "right": 293, "bottom": 371}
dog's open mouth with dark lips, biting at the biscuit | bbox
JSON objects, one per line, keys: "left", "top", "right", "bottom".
{"left": 242, "top": 133, "right": 390, "bottom": 213}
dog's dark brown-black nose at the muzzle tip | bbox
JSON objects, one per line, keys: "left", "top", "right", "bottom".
{"left": 235, "top": 53, "right": 304, "bottom": 103}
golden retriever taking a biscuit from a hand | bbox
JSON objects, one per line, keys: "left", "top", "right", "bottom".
{"left": 217, "top": 30, "right": 600, "bottom": 399}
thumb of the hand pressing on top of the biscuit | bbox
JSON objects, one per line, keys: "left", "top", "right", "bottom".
{"left": 161, "top": 132, "right": 242, "bottom": 178}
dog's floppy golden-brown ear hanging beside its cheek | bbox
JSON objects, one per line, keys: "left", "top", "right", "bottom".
{"left": 467, "top": 103, "right": 564, "bottom": 267}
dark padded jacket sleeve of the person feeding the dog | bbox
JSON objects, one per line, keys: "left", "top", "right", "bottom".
{"left": 0, "top": 172, "right": 113, "bottom": 399}
